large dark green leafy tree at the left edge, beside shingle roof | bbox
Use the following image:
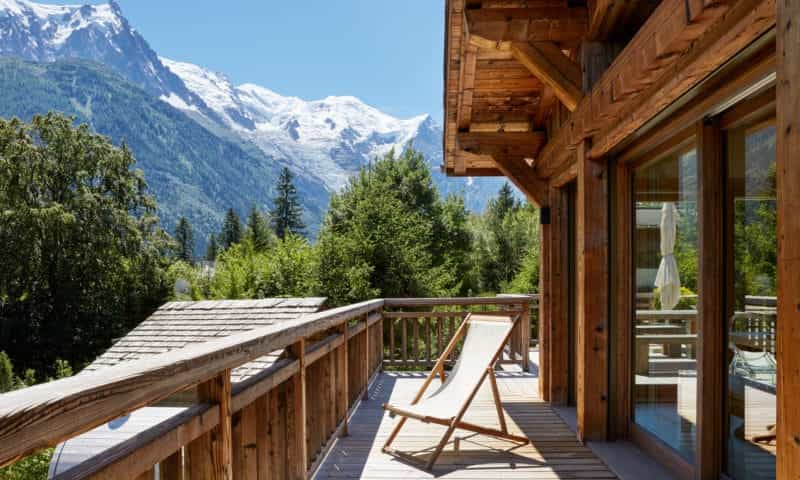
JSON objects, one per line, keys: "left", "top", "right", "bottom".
{"left": 0, "top": 114, "right": 169, "bottom": 373}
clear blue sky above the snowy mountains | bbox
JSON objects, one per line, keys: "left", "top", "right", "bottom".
{"left": 47, "top": 0, "right": 444, "bottom": 123}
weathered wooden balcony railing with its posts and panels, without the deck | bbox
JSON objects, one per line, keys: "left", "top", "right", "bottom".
{"left": 0, "top": 297, "right": 530, "bottom": 480}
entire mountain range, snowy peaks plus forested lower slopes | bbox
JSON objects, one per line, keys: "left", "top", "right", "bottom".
{"left": 0, "top": 0, "right": 512, "bottom": 246}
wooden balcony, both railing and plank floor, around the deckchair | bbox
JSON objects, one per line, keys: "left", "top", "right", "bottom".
{"left": 0, "top": 296, "right": 614, "bottom": 479}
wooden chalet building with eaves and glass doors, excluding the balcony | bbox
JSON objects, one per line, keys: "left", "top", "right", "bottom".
{"left": 443, "top": 0, "right": 800, "bottom": 479}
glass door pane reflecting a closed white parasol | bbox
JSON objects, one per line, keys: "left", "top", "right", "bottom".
{"left": 633, "top": 149, "right": 698, "bottom": 462}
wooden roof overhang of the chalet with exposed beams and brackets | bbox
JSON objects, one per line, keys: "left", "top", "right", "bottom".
{"left": 443, "top": 0, "right": 776, "bottom": 203}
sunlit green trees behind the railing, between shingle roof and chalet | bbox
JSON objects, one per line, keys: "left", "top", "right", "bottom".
{"left": 169, "top": 149, "right": 539, "bottom": 306}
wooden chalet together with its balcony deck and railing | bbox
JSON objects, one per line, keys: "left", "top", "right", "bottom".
{"left": 0, "top": 0, "right": 800, "bottom": 480}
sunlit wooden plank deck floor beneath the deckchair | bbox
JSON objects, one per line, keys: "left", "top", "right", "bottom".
{"left": 315, "top": 372, "right": 617, "bottom": 480}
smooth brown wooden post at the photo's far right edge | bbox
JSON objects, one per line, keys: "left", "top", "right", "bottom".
{"left": 776, "top": 0, "right": 800, "bottom": 479}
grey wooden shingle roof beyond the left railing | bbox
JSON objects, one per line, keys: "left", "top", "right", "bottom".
{"left": 86, "top": 297, "right": 325, "bottom": 382}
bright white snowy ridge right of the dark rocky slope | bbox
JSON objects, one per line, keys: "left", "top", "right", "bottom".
{"left": 161, "top": 58, "right": 441, "bottom": 191}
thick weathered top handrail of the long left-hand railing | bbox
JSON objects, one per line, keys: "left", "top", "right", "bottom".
{"left": 0, "top": 299, "right": 384, "bottom": 464}
